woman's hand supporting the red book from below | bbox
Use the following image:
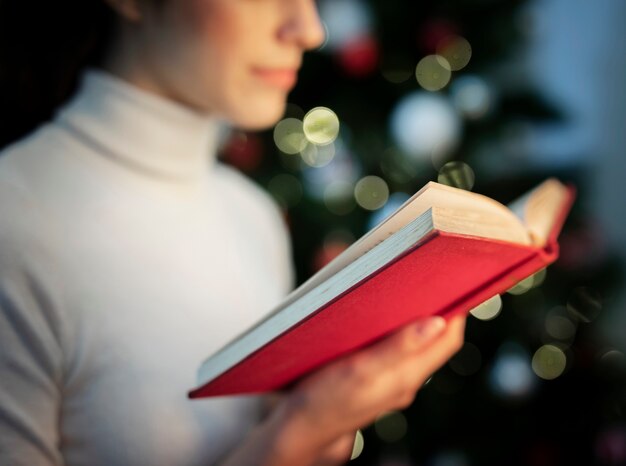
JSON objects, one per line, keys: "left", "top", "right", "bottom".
{"left": 218, "top": 316, "right": 465, "bottom": 466}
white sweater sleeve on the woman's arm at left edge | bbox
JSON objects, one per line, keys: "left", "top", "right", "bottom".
{"left": 0, "top": 181, "right": 64, "bottom": 466}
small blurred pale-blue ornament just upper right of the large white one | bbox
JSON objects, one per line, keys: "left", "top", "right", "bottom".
{"left": 450, "top": 75, "right": 494, "bottom": 120}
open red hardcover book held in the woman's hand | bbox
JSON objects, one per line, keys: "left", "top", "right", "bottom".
{"left": 189, "top": 179, "right": 574, "bottom": 398}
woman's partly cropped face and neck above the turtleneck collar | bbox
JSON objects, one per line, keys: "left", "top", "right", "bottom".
{"left": 112, "top": 0, "right": 324, "bottom": 129}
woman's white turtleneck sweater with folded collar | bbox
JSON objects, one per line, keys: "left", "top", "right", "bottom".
{"left": 0, "top": 70, "right": 292, "bottom": 466}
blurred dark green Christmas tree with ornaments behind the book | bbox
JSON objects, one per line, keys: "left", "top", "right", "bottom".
{"left": 222, "top": 0, "right": 626, "bottom": 466}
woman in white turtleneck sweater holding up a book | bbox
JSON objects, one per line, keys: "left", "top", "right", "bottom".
{"left": 0, "top": 0, "right": 464, "bottom": 466}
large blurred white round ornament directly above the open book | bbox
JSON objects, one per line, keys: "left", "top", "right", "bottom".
{"left": 390, "top": 91, "right": 461, "bottom": 161}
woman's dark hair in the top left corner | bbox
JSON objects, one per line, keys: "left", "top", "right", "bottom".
{"left": 0, "top": 0, "right": 116, "bottom": 148}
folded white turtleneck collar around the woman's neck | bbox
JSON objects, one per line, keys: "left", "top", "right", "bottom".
{"left": 55, "top": 68, "right": 221, "bottom": 181}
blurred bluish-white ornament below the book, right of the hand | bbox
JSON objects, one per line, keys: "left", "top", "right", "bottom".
{"left": 489, "top": 342, "right": 535, "bottom": 398}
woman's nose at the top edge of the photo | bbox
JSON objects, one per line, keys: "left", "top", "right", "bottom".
{"left": 280, "top": 0, "right": 326, "bottom": 50}
